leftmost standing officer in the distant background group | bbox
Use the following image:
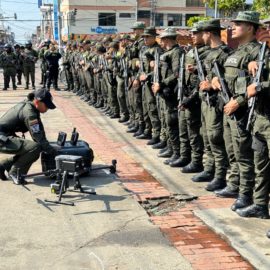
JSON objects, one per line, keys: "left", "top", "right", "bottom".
{"left": 0, "top": 44, "right": 17, "bottom": 90}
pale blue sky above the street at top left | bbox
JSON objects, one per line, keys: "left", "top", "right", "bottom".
{"left": 0, "top": 0, "right": 48, "bottom": 43}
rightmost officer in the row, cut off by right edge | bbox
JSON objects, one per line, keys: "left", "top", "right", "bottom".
{"left": 236, "top": 15, "right": 270, "bottom": 220}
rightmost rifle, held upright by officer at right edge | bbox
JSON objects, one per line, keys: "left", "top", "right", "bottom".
{"left": 246, "top": 42, "right": 266, "bottom": 132}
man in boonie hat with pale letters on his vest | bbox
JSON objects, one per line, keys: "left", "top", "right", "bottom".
{"left": 212, "top": 11, "right": 260, "bottom": 211}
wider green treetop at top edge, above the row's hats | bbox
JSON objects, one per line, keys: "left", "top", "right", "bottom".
{"left": 204, "top": 0, "right": 245, "bottom": 17}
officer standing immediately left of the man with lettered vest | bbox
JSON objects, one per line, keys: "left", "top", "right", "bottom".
{"left": 193, "top": 19, "right": 231, "bottom": 192}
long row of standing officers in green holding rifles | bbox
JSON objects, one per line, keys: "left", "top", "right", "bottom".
{"left": 63, "top": 11, "right": 270, "bottom": 221}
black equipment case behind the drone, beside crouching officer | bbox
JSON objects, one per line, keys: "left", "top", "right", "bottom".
{"left": 41, "top": 129, "right": 94, "bottom": 172}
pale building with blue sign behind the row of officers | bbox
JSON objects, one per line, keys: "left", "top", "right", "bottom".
{"left": 60, "top": 0, "right": 205, "bottom": 40}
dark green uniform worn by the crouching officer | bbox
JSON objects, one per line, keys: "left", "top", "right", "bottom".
{"left": 0, "top": 101, "right": 55, "bottom": 175}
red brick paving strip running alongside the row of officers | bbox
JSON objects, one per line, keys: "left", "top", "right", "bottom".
{"left": 54, "top": 92, "right": 254, "bottom": 270}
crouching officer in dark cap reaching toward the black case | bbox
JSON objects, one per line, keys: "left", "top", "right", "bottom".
{"left": 0, "top": 89, "right": 56, "bottom": 185}
